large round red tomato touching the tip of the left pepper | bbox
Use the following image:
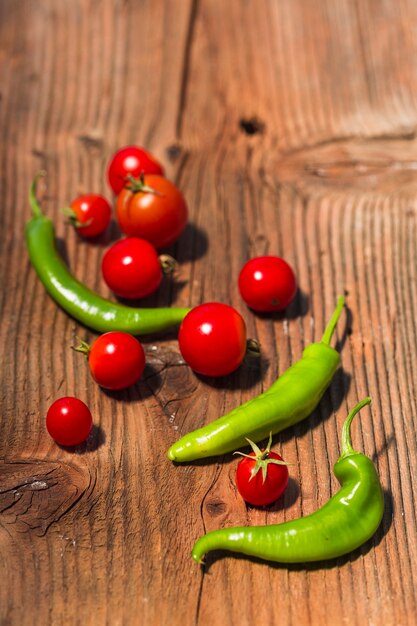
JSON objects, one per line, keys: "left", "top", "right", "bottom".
{"left": 178, "top": 302, "right": 246, "bottom": 376}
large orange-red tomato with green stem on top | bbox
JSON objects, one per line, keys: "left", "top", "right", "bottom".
{"left": 116, "top": 175, "right": 188, "bottom": 248}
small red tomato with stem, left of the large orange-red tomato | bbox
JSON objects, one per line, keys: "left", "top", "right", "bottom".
{"left": 69, "top": 193, "right": 111, "bottom": 237}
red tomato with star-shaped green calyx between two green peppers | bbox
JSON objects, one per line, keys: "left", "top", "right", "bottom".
{"left": 235, "top": 436, "right": 288, "bottom": 506}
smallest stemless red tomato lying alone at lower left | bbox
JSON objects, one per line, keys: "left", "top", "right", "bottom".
{"left": 46, "top": 396, "right": 93, "bottom": 446}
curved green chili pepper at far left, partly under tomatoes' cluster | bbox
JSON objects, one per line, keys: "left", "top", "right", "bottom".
{"left": 26, "top": 172, "right": 190, "bottom": 335}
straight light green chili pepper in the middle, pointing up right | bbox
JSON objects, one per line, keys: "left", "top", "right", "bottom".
{"left": 168, "top": 296, "right": 344, "bottom": 463}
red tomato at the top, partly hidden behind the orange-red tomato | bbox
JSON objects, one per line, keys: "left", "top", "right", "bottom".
{"left": 107, "top": 146, "right": 164, "bottom": 195}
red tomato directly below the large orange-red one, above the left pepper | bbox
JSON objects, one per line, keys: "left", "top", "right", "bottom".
{"left": 101, "top": 237, "right": 162, "bottom": 299}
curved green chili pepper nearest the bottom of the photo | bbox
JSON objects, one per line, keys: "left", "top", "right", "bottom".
{"left": 192, "top": 398, "right": 384, "bottom": 563}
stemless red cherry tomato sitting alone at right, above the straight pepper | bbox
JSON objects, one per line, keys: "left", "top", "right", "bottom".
{"left": 239, "top": 256, "right": 297, "bottom": 312}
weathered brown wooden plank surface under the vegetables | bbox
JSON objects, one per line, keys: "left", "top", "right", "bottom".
{"left": 0, "top": 0, "right": 417, "bottom": 626}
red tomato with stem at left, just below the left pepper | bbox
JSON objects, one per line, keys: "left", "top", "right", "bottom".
{"left": 84, "top": 331, "right": 145, "bottom": 390}
